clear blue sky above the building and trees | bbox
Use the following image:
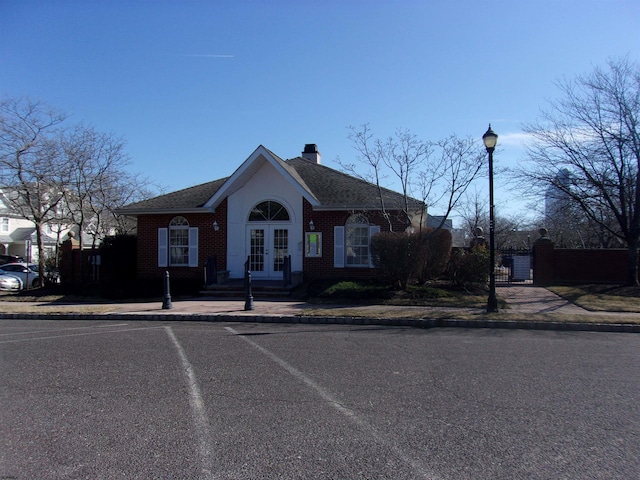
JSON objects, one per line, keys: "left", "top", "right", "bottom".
{"left": 0, "top": 0, "right": 640, "bottom": 223}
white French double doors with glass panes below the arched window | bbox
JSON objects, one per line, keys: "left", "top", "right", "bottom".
{"left": 247, "top": 224, "right": 289, "bottom": 279}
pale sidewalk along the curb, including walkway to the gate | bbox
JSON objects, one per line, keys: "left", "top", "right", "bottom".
{"left": 0, "top": 285, "right": 640, "bottom": 332}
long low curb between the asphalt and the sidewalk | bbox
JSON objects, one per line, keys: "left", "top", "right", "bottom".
{"left": 0, "top": 313, "right": 640, "bottom": 333}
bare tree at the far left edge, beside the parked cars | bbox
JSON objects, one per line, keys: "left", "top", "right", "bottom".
{"left": 0, "top": 98, "right": 66, "bottom": 278}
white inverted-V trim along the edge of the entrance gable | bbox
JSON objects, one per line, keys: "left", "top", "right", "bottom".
{"left": 203, "top": 145, "right": 320, "bottom": 209}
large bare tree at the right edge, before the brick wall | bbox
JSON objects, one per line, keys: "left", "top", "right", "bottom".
{"left": 519, "top": 59, "right": 640, "bottom": 285}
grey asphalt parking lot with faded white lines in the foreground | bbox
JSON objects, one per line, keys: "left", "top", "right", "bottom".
{"left": 0, "top": 320, "right": 640, "bottom": 479}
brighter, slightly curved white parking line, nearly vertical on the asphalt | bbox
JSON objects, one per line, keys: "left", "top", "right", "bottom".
{"left": 164, "top": 327, "right": 214, "bottom": 479}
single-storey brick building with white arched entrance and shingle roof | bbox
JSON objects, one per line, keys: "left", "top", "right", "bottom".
{"left": 117, "top": 144, "right": 426, "bottom": 281}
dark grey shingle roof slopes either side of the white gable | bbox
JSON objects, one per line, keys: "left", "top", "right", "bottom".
{"left": 119, "top": 152, "right": 422, "bottom": 214}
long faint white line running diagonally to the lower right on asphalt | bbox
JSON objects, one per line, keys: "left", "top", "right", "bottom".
{"left": 224, "top": 327, "right": 438, "bottom": 480}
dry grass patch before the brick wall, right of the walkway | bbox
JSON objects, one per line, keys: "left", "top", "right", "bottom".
{"left": 548, "top": 284, "right": 640, "bottom": 313}
